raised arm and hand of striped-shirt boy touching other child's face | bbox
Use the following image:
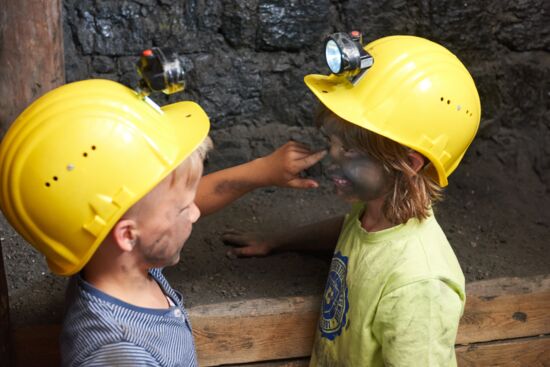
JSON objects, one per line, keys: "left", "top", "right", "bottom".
{"left": 195, "top": 141, "right": 326, "bottom": 215}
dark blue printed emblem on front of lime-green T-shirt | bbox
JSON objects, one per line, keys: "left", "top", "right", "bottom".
{"left": 319, "top": 252, "right": 349, "bottom": 340}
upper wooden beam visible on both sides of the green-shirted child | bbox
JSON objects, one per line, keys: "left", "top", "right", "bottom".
{"left": 189, "top": 275, "right": 550, "bottom": 366}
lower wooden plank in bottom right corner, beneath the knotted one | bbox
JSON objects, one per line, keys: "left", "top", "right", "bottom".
{"left": 456, "top": 336, "right": 550, "bottom": 367}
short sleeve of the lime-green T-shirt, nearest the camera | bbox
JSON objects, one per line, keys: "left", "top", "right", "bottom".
{"left": 373, "top": 279, "right": 462, "bottom": 367}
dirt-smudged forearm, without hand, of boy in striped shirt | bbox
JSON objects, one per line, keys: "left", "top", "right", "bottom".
{"left": 195, "top": 158, "right": 269, "bottom": 215}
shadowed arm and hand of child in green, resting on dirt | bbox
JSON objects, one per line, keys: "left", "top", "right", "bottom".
{"left": 222, "top": 216, "right": 344, "bottom": 257}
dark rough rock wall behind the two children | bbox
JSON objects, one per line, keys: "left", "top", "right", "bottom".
{"left": 64, "top": 0, "right": 550, "bottom": 186}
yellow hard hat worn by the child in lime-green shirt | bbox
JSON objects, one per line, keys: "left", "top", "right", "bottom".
{"left": 305, "top": 36, "right": 481, "bottom": 187}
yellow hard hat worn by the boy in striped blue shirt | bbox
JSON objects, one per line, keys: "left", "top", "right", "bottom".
{"left": 0, "top": 80, "right": 210, "bottom": 275}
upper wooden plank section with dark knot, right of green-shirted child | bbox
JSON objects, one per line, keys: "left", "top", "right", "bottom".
{"left": 456, "top": 275, "right": 550, "bottom": 344}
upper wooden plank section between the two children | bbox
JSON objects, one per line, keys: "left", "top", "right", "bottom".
{"left": 189, "top": 297, "right": 320, "bottom": 366}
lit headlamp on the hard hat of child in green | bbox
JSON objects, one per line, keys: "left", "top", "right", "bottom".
{"left": 325, "top": 31, "right": 374, "bottom": 84}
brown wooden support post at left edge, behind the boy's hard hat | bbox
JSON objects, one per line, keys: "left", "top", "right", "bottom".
{"left": 0, "top": 0, "right": 65, "bottom": 362}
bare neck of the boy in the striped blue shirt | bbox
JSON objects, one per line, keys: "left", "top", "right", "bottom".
{"left": 82, "top": 243, "right": 168, "bottom": 308}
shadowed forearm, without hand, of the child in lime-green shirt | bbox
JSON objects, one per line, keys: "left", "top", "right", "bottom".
{"left": 273, "top": 216, "right": 344, "bottom": 252}
